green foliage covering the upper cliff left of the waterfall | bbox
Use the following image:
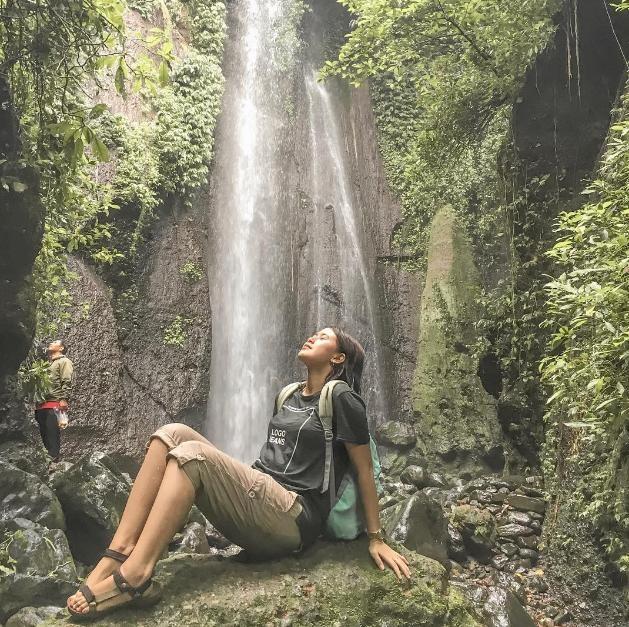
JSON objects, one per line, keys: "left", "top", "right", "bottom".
{"left": 0, "top": 0, "right": 225, "bottom": 337}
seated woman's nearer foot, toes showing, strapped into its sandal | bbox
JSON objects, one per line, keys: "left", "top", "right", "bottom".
{"left": 68, "top": 568, "right": 156, "bottom": 615}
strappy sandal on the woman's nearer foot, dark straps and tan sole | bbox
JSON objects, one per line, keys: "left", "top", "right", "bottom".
{"left": 68, "top": 558, "right": 162, "bottom": 622}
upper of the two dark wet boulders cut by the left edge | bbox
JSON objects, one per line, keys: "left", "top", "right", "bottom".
{"left": 0, "top": 460, "right": 66, "bottom": 529}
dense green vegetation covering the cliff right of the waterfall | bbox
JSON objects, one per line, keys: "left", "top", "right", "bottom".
{"left": 323, "top": 0, "right": 629, "bottom": 574}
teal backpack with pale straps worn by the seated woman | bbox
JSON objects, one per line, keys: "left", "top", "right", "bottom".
{"left": 275, "top": 379, "right": 382, "bottom": 540}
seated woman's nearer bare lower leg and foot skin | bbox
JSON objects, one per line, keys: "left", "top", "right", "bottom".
{"left": 71, "top": 459, "right": 195, "bottom": 612}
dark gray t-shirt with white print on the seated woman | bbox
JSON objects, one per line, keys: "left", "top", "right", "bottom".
{"left": 253, "top": 388, "right": 369, "bottom": 544}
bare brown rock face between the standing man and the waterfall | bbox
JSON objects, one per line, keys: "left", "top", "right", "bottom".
{"left": 62, "top": 210, "right": 211, "bottom": 458}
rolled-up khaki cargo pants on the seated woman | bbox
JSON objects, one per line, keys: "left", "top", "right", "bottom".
{"left": 149, "top": 423, "right": 302, "bottom": 557}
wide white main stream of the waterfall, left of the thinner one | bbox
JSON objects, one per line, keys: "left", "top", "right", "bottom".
{"left": 208, "top": 0, "right": 294, "bottom": 461}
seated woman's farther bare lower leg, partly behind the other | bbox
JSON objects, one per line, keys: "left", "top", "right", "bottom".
{"left": 68, "top": 438, "right": 168, "bottom": 603}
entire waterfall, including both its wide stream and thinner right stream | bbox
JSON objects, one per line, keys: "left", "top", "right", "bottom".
{"left": 207, "top": 0, "right": 384, "bottom": 462}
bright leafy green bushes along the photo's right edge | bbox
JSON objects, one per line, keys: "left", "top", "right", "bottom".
{"left": 541, "top": 89, "right": 629, "bottom": 570}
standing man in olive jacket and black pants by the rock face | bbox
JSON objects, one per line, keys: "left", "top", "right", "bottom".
{"left": 35, "top": 340, "right": 74, "bottom": 462}
